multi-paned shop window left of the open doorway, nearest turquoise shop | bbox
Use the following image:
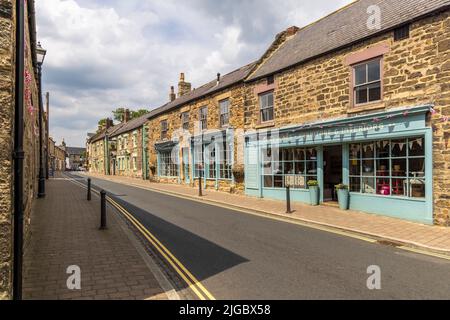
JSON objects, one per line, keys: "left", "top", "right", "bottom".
{"left": 262, "top": 148, "right": 317, "bottom": 189}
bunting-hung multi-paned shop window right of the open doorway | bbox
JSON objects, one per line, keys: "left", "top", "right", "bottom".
{"left": 349, "top": 137, "right": 426, "bottom": 198}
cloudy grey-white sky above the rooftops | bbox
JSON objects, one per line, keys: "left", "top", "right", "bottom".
{"left": 36, "top": 0, "right": 352, "bottom": 147}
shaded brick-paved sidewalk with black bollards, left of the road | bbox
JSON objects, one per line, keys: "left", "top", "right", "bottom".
{"left": 23, "top": 176, "right": 176, "bottom": 300}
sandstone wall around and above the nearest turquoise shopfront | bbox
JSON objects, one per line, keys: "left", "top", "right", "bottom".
{"left": 244, "top": 11, "right": 450, "bottom": 225}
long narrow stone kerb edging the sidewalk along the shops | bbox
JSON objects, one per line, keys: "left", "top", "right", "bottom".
{"left": 82, "top": 175, "right": 450, "bottom": 257}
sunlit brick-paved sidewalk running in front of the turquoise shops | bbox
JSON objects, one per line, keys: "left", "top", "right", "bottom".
{"left": 85, "top": 174, "right": 450, "bottom": 254}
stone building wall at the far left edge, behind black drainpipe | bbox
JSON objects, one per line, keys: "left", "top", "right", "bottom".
{"left": 0, "top": 0, "right": 40, "bottom": 299}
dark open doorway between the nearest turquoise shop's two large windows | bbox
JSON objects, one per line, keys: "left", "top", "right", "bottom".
{"left": 323, "top": 145, "right": 343, "bottom": 202}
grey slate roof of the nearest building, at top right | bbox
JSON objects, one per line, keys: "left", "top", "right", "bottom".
{"left": 248, "top": 0, "right": 450, "bottom": 80}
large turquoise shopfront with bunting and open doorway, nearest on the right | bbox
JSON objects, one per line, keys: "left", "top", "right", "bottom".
{"left": 244, "top": 105, "right": 433, "bottom": 224}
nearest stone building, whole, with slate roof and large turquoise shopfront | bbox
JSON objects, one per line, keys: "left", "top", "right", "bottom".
{"left": 244, "top": 0, "right": 450, "bottom": 225}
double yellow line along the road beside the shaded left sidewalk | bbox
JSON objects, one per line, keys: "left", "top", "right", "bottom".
{"left": 63, "top": 177, "right": 216, "bottom": 300}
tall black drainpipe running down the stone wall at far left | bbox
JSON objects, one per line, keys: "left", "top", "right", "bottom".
{"left": 13, "top": 0, "right": 25, "bottom": 300}
